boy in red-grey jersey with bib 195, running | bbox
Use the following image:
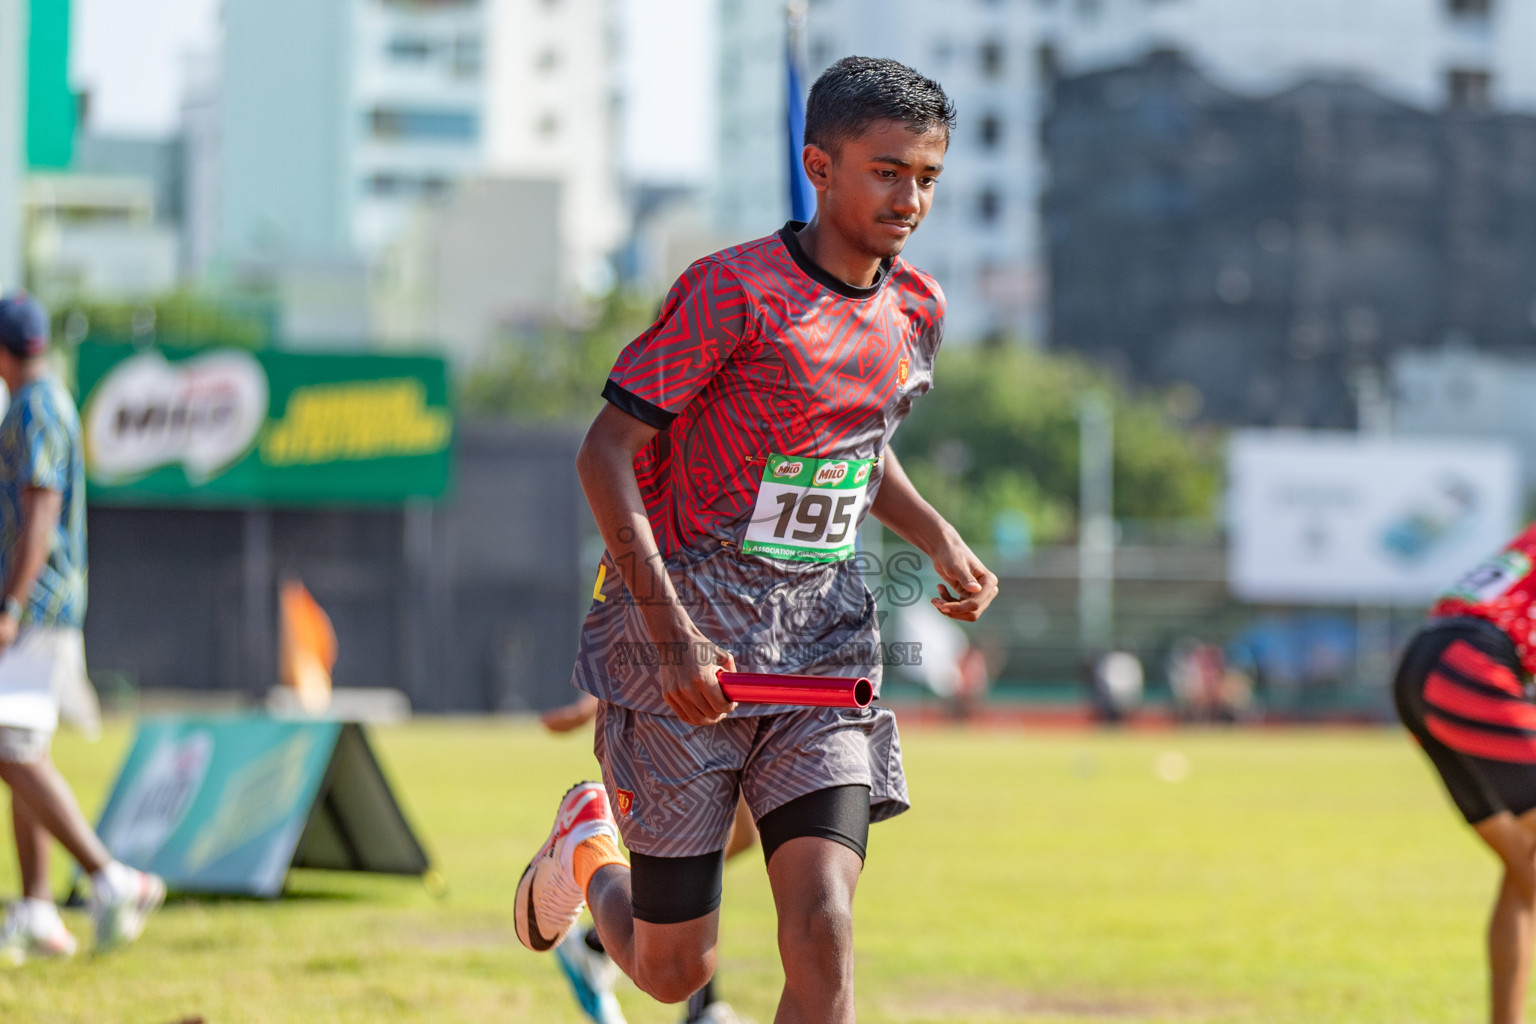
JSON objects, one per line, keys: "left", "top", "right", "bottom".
{"left": 516, "top": 57, "right": 997, "bottom": 1024}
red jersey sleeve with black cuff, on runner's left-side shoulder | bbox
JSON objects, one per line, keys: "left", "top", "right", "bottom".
{"left": 602, "top": 259, "right": 751, "bottom": 430}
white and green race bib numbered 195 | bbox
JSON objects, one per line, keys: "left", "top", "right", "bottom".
{"left": 742, "top": 454, "right": 874, "bottom": 562}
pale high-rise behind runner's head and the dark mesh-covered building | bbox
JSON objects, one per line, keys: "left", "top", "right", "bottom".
{"left": 716, "top": 0, "right": 1536, "bottom": 348}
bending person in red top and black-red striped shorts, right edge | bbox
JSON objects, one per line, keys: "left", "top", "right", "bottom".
{"left": 1393, "top": 525, "right": 1536, "bottom": 1024}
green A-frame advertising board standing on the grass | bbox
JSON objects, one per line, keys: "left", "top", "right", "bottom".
{"left": 97, "top": 715, "right": 429, "bottom": 897}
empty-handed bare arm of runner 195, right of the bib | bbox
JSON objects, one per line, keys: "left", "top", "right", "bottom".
{"left": 869, "top": 448, "right": 997, "bottom": 622}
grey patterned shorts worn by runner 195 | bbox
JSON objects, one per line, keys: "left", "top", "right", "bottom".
{"left": 596, "top": 702, "right": 911, "bottom": 857}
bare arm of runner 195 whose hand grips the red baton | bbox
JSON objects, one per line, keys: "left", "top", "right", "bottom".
{"left": 576, "top": 405, "right": 736, "bottom": 725}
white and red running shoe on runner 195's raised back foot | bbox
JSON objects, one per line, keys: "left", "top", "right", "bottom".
{"left": 513, "top": 783, "right": 619, "bottom": 953}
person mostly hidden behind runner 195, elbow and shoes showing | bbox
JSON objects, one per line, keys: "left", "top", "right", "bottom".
{"left": 539, "top": 694, "right": 757, "bottom": 1024}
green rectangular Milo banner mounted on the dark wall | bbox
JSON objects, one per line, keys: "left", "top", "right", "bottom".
{"left": 77, "top": 342, "right": 453, "bottom": 505}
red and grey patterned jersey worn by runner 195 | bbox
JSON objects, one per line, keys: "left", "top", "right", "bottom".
{"left": 574, "top": 223, "right": 945, "bottom": 714}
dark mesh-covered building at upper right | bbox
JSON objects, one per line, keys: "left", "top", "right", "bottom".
{"left": 1043, "top": 54, "right": 1536, "bottom": 427}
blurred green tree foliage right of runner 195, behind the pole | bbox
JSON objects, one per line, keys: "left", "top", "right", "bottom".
{"left": 894, "top": 347, "right": 1218, "bottom": 543}
